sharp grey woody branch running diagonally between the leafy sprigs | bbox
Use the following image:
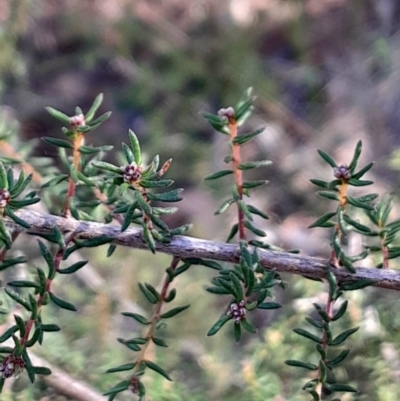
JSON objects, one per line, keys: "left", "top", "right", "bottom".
{"left": 6, "top": 206, "right": 400, "bottom": 291}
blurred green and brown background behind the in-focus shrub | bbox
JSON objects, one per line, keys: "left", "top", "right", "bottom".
{"left": 0, "top": 0, "right": 400, "bottom": 401}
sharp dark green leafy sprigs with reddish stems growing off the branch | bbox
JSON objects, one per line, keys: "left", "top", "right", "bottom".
{"left": 0, "top": 90, "right": 400, "bottom": 401}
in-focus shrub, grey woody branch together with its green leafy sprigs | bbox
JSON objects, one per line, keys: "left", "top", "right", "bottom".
{"left": 0, "top": 90, "right": 400, "bottom": 401}
